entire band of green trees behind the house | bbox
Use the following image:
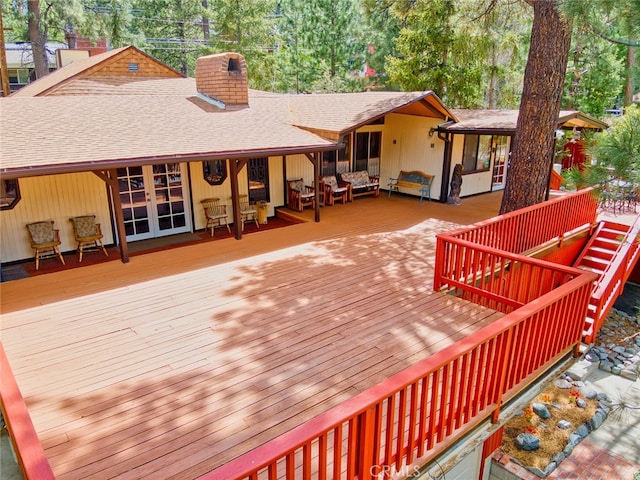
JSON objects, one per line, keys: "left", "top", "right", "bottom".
{"left": 3, "top": 0, "right": 640, "bottom": 100}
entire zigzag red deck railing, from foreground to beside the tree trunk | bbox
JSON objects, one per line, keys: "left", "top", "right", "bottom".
{"left": 201, "top": 189, "right": 597, "bottom": 480}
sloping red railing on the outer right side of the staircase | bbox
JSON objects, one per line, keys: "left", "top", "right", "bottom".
{"left": 585, "top": 215, "right": 640, "bottom": 343}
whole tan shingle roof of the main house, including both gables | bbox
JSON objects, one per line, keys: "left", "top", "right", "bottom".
{"left": 0, "top": 47, "right": 453, "bottom": 178}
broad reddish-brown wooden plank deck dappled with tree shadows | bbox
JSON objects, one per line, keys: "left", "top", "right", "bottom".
{"left": 1, "top": 193, "right": 502, "bottom": 480}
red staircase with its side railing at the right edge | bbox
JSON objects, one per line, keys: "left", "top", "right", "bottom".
{"left": 573, "top": 221, "right": 638, "bottom": 343}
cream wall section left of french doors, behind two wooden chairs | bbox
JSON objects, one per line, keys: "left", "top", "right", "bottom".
{"left": 0, "top": 172, "right": 114, "bottom": 263}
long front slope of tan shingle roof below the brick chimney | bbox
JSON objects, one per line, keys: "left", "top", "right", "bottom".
{"left": 0, "top": 95, "right": 335, "bottom": 175}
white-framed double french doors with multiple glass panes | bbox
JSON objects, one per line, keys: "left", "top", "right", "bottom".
{"left": 118, "top": 163, "right": 191, "bottom": 241}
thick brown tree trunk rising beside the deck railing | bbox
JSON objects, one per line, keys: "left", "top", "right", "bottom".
{"left": 500, "top": 0, "right": 571, "bottom": 213}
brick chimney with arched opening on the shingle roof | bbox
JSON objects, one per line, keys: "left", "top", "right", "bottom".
{"left": 196, "top": 52, "right": 249, "bottom": 108}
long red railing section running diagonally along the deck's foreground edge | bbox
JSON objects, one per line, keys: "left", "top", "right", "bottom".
{"left": 201, "top": 272, "right": 595, "bottom": 480}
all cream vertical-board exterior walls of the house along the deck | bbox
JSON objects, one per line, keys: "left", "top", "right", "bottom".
{"left": 0, "top": 114, "right": 444, "bottom": 263}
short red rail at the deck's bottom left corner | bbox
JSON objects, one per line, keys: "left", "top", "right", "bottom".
{"left": 0, "top": 343, "right": 55, "bottom": 480}
